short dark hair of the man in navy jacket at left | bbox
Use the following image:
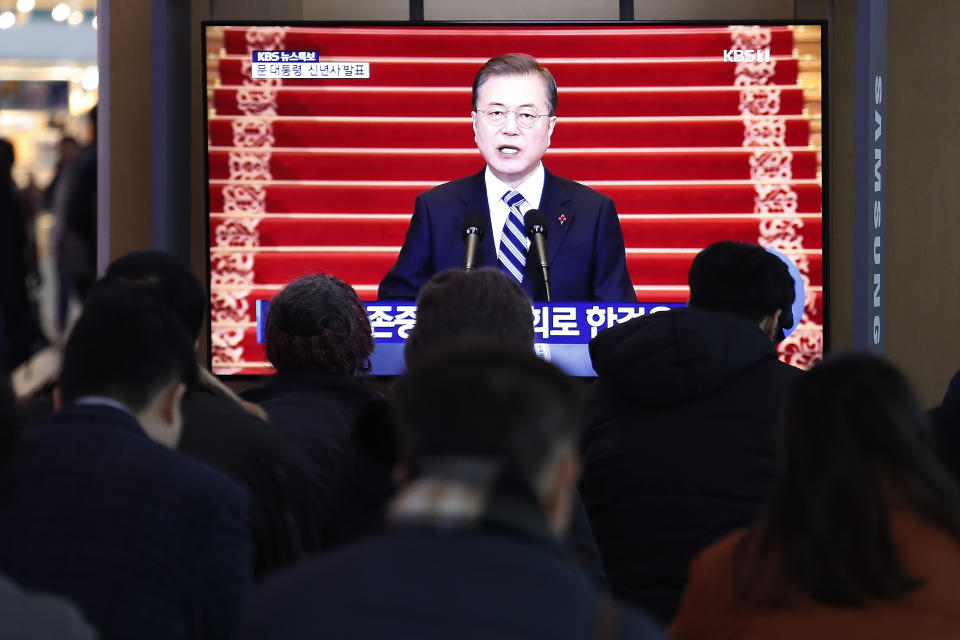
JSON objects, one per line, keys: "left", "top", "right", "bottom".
{"left": 60, "top": 281, "right": 197, "bottom": 413}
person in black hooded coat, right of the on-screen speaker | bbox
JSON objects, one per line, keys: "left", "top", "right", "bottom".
{"left": 580, "top": 242, "right": 801, "bottom": 622}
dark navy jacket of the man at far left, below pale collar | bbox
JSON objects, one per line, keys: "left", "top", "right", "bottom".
{"left": 0, "top": 405, "right": 252, "bottom": 640}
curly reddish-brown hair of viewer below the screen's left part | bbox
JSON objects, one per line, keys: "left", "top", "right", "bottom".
{"left": 266, "top": 273, "right": 373, "bottom": 375}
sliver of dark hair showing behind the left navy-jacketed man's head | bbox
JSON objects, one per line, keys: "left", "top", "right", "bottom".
{"left": 104, "top": 250, "right": 207, "bottom": 340}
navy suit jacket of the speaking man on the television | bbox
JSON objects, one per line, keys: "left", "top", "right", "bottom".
{"left": 377, "top": 171, "right": 637, "bottom": 302}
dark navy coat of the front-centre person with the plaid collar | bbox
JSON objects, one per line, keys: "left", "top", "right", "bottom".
{"left": 240, "top": 478, "right": 665, "bottom": 640}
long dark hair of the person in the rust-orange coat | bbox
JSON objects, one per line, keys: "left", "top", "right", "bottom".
{"left": 738, "top": 354, "right": 960, "bottom": 605}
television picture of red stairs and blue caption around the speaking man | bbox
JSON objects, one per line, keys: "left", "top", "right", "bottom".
{"left": 204, "top": 22, "right": 825, "bottom": 375}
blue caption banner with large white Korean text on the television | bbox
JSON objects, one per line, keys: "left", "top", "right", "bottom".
{"left": 256, "top": 300, "right": 685, "bottom": 376}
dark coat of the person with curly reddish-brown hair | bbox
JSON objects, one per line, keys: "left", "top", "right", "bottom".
{"left": 242, "top": 369, "right": 393, "bottom": 551}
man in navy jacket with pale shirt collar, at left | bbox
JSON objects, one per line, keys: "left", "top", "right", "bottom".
{"left": 0, "top": 283, "right": 253, "bottom": 640}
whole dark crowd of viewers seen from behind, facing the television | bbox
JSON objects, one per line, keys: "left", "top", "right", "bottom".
{"left": 0, "top": 242, "right": 960, "bottom": 640}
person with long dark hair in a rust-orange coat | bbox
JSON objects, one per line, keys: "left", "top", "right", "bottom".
{"left": 672, "top": 354, "right": 960, "bottom": 640}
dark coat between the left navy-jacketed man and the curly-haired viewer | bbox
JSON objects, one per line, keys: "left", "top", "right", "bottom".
{"left": 177, "top": 389, "right": 321, "bottom": 579}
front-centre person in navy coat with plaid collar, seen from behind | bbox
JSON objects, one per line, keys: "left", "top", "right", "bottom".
{"left": 240, "top": 342, "right": 664, "bottom": 640}
